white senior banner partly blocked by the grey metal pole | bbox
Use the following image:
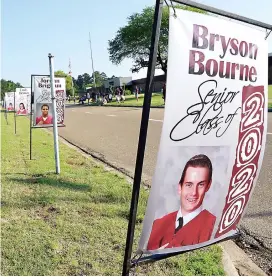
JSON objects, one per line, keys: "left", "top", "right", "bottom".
{"left": 32, "top": 75, "right": 66, "bottom": 127}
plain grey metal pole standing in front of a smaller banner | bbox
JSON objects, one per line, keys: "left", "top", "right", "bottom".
{"left": 48, "top": 53, "right": 60, "bottom": 174}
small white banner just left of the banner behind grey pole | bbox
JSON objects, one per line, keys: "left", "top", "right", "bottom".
{"left": 15, "top": 88, "right": 31, "bottom": 115}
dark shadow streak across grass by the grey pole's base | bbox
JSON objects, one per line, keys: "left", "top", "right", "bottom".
{"left": 9, "top": 175, "right": 91, "bottom": 191}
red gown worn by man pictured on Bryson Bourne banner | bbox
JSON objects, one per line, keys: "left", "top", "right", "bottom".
{"left": 147, "top": 210, "right": 216, "bottom": 250}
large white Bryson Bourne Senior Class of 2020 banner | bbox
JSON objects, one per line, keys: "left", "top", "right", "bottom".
{"left": 138, "top": 9, "right": 268, "bottom": 253}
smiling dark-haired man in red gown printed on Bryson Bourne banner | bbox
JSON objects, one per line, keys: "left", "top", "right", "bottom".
{"left": 147, "top": 155, "right": 216, "bottom": 250}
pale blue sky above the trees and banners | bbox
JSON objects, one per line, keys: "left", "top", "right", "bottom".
{"left": 1, "top": 0, "right": 272, "bottom": 86}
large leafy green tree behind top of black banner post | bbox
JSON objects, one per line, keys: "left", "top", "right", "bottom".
{"left": 108, "top": 5, "right": 205, "bottom": 74}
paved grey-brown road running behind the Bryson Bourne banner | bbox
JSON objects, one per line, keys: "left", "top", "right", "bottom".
{"left": 59, "top": 106, "right": 272, "bottom": 274}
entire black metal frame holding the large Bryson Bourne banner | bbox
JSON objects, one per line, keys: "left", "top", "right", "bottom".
{"left": 122, "top": 0, "right": 272, "bottom": 276}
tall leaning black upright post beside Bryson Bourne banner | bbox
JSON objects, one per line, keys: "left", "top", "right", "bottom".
{"left": 122, "top": 0, "right": 164, "bottom": 276}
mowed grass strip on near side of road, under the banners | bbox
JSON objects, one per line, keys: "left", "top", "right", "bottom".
{"left": 1, "top": 114, "right": 224, "bottom": 276}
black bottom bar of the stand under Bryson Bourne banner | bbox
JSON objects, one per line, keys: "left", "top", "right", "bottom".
{"left": 130, "top": 230, "right": 241, "bottom": 268}
